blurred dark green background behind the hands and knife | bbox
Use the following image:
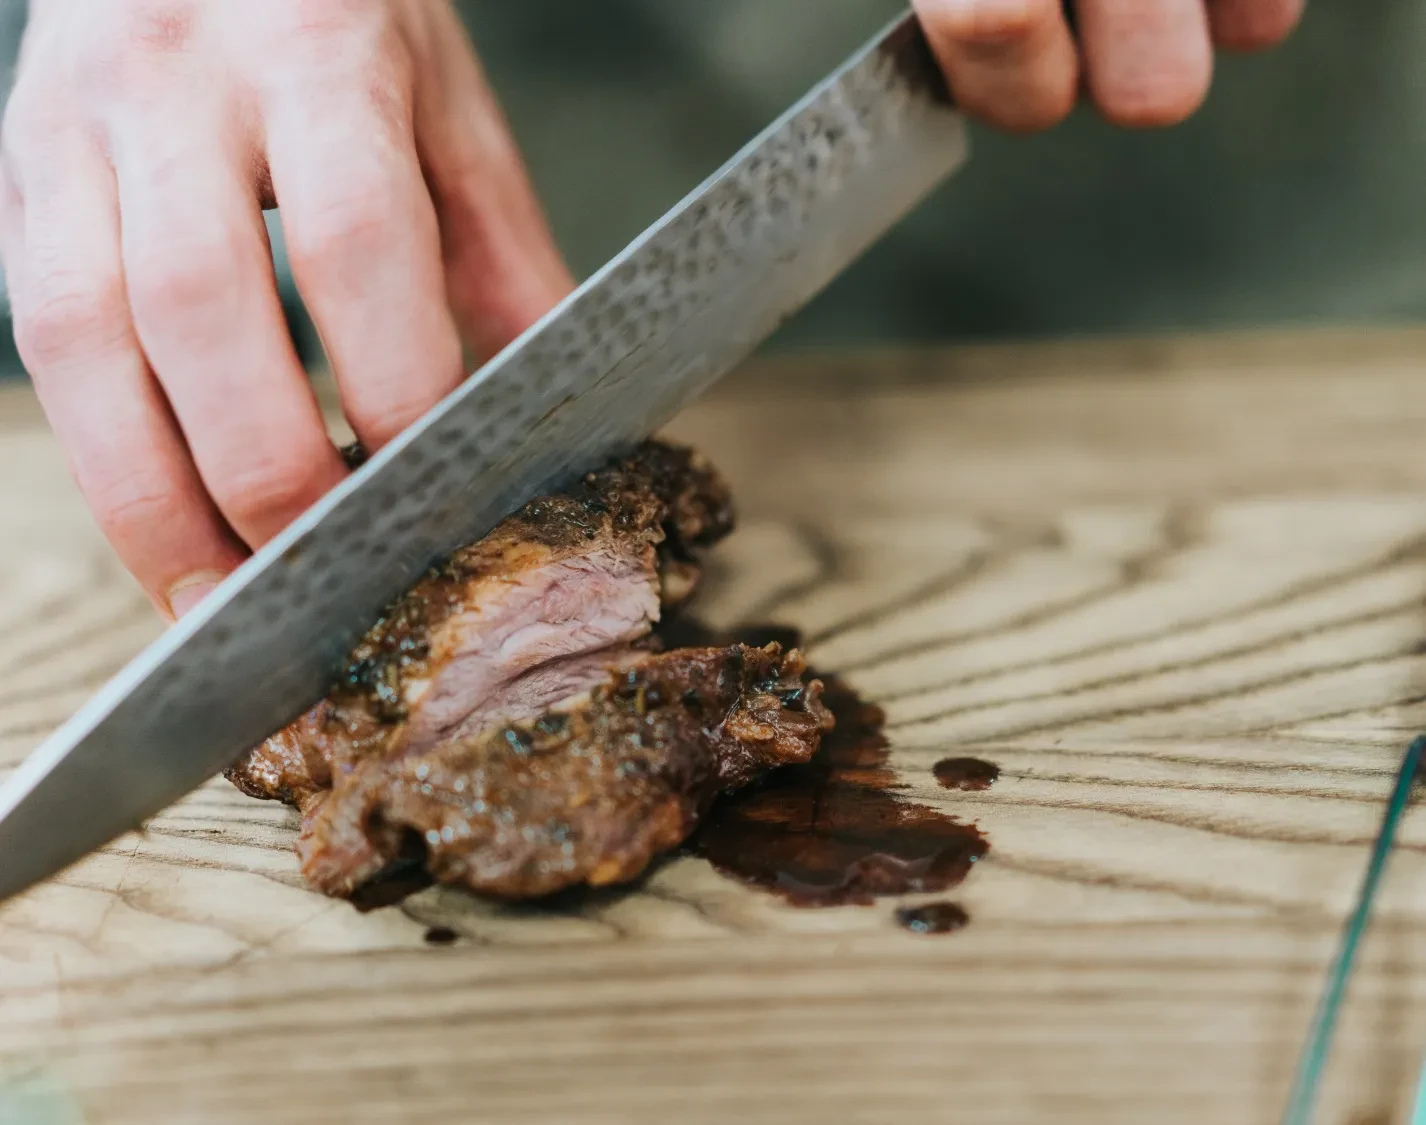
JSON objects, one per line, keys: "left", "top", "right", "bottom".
{"left": 0, "top": 0, "right": 1426, "bottom": 370}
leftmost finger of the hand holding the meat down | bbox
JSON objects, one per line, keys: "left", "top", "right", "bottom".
{"left": 4, "top": 128, "right": 247, "bottom": 617}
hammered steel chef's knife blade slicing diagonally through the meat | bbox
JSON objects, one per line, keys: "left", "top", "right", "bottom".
{"left": 0, "top": 14, "right": 967, "bottom": 898}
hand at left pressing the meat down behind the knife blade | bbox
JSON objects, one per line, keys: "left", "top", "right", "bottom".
{"left": 0, "top": 0, "right": 572, "bottom": 616}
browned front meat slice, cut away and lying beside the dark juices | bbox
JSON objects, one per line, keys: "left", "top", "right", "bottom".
{"left": 298, "top": 643, "right": 831, "bottom": 898}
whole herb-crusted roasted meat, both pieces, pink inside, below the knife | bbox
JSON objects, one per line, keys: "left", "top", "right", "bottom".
{"left": 227, "top": 442, "right": 830, "bottom": 897}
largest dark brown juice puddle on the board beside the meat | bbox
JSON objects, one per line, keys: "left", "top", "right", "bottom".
{"left": 670, "top": 618, "right": 994, "bottom": 906}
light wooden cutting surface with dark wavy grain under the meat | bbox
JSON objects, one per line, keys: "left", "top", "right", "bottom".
{"left": 0, "top": 332, "right": 1426, "bottom": 1125}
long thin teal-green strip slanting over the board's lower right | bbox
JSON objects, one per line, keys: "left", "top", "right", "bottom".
{"left": 1282, "top": 734, "right": 1426, "bottom": 1125}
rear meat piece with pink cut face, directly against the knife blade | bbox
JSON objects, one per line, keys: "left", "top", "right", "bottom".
{"left": 227, "top": 442, "right": 732, "bottom": 807}
